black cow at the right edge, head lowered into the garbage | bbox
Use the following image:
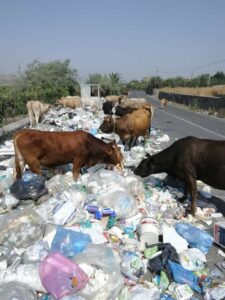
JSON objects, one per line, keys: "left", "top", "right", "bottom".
{"left": 134, "top": 137, "right": 225, "bottom": 215}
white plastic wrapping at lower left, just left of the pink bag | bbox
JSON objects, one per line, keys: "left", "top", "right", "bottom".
{"left": 0, "top": 264, "right": 46, "bottom": 292}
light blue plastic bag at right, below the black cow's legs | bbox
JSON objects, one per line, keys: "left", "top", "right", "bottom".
{"left": 175, "top": 222, "right": 213, "bottom": 254}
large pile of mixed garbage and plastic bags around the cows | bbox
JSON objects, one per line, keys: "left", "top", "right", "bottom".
{"left": 0, "top": 103, "right": 225, "bottom": 300}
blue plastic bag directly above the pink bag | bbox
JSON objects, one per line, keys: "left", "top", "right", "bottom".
{"left": 51, "top": 226, "right": 92, "bottom": 258}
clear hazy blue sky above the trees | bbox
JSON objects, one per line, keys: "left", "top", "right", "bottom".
{"left": 0, "top": 0, "right": 225, "bottom": 81}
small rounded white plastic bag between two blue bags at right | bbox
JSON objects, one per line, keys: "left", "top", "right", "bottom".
{"left": 179, "top": 248, "right": 206, "bottom": 271}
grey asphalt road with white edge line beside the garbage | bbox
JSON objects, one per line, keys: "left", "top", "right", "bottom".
{"left": 129, "top": 91, "right": 225, "bottom": 203}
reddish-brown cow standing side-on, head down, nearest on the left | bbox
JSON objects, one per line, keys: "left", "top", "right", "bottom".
{"left": 14, "top": 129, "right": 123, "bottom": 179}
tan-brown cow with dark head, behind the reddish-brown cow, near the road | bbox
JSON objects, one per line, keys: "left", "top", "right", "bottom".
{"left": 99, "top": 105, "right": 153, "bottom": 150}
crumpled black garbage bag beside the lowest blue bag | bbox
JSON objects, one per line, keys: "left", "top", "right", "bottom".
{"left": 146, "top": 243, "right": 179, "bottom": 274}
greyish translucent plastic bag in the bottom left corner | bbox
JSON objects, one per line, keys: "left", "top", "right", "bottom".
{"left": 0, "top": 281, "right": 38, "bottom": 300}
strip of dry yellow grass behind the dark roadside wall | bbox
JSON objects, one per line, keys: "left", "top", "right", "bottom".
{"left": 160, "top": 85, "right": 225, "bottom": 97}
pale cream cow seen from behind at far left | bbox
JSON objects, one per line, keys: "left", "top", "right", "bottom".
{"left": 26, "top": 100, "right": 51, "bottom": 127}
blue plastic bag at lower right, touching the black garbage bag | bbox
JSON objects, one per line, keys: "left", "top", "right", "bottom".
{"left": 168, "top": 260, "right": 202, "bottom": 294}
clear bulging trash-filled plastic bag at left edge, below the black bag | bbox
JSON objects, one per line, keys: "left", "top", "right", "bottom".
{"left": 0, "top": 208, "right": 45, "bottom": 248}
